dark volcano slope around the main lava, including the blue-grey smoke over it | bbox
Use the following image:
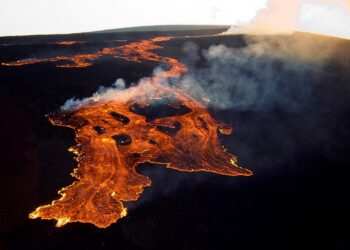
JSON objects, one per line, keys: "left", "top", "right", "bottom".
{"left": 0, "top": 27, "right": 350, "bottom": 249}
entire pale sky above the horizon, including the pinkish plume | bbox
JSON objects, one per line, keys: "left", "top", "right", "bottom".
{"left": 0, "top": 0, "right": 350, "bottom": 39}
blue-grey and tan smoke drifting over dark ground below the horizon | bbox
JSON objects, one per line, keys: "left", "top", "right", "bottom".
{"left": 176, "top": 33, "right": 336, "bottom": 111}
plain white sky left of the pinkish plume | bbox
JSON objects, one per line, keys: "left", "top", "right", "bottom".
{"left": 0, "top": 0, "right": 266, "bottom": 36}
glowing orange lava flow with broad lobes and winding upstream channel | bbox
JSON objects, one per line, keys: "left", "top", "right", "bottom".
{"left": 26, "top": 37, "right": 252, "bottom": 228}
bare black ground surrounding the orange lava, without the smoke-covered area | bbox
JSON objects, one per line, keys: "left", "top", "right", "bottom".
{"left": 0, "top": 27, "right": 350, "bottom": 250}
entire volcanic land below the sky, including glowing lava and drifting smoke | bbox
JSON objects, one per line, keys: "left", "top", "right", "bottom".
{"left": 0, "top": 27, "right": 350, "bottom": 249}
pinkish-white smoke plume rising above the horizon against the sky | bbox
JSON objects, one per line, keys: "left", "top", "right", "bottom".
{"left": 227, "top": 0, "right": 350, "bottom": 38}
